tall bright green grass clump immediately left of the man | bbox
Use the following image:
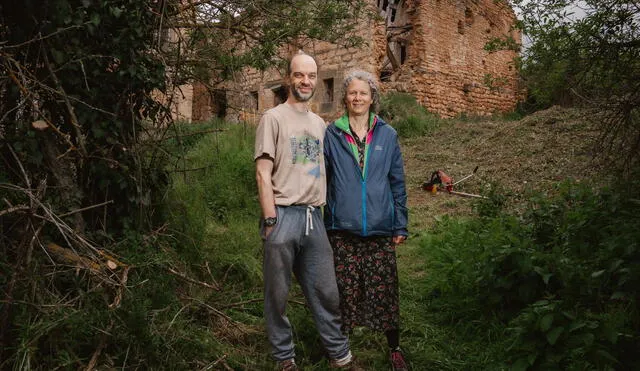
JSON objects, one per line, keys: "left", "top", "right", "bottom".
{"left": 166, "top": 125, "right": 260, "bottom": 285}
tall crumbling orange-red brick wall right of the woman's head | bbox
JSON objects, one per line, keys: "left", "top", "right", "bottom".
{"left": 383, "top": 0, "right": 520, "bottom": 117}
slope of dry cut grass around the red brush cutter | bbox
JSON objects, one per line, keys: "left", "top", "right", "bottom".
{"left": 402, "top": 107, "right": 599, "bottom": 231}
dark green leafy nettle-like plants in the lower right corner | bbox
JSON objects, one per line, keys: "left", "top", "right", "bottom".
{"left": 479, "top": 183, "right": 640, "bottom": 370}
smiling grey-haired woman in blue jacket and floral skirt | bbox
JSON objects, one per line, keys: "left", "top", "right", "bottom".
{"left": 324, "top": 71, "right": 407, "bottom": 370}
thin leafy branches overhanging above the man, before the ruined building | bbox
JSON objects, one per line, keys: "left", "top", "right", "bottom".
{"left": 170, "top": 0, "right": 374, "bottom": 85}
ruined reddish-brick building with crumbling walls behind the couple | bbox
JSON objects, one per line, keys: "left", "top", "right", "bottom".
{"left": 192, "top": 0, "right": 521, "bottom": 122}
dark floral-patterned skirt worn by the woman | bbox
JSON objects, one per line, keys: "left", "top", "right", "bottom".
{"left": 329, "top": 231, "right": 400, "bottom": 332}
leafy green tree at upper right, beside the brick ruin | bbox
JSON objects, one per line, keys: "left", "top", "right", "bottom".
{"left": 504, "top": 0, "right": 640, "bottom": 174}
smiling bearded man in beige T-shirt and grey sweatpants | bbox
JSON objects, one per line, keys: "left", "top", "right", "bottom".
{"left": 254, "top": 53, "right": 356, "bottom": 370}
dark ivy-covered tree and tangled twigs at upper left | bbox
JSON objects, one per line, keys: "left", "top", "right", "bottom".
{"left": 0, "top": 0, "right": 172, "bottom": 232}
